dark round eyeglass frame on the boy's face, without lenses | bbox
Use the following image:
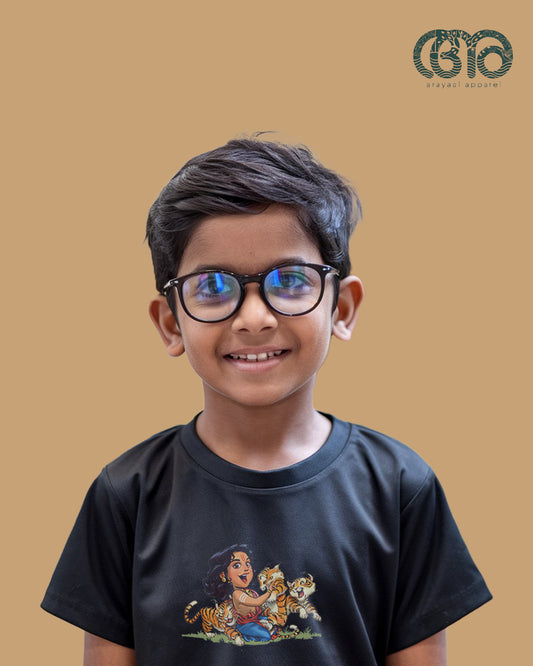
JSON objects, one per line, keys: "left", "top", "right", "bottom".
{"left": 161, "top": 262, "right": 340, "bottom": 324}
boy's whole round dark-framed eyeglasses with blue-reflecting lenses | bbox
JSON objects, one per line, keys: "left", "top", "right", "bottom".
{"left": 163, "top": 264, "right": 339, "bottom": 323}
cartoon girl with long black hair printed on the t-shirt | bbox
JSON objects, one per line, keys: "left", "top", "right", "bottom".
{"left": 204, "top": 544, "right": 272, "bottom": 642}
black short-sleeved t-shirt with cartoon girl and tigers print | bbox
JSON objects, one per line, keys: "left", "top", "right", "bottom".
{"left": 42, "top": 412, "right": 491, "bottom": 666}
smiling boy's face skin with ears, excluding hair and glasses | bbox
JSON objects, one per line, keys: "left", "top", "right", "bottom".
{"left": 151, "top": 205, "right": 362, "bottom": 409}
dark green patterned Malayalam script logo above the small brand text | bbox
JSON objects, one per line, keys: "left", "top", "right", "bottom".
{"left": 413, "top": 30, "right": 513, "bottom": 79}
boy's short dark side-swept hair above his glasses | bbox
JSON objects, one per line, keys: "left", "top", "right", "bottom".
{"left": 146, "top": 133, "right": 361, "bottom": 293}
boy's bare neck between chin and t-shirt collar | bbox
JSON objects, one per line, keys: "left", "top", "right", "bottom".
{"left": 196, "top": 399, "right": 331, "bottom": 471}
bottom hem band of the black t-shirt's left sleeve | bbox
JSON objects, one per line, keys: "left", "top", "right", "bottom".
{"left": 41, "top": 590, "right": 134, "bottom": 649}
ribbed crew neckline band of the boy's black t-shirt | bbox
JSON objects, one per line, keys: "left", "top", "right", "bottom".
{"left": 181, "top": 414, "right": 351, "bottom": 488}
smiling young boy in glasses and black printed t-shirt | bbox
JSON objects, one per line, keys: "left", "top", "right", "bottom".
{"left": 43, "top": 138, "right": 491, "bottom": 666}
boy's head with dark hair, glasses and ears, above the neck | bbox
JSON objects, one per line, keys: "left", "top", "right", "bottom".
{"left": 148, "top": 139, "right": 363, "bottom": 406}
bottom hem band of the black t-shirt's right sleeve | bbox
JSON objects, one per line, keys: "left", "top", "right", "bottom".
{"left": 387, "top": 580, "right": 492, "bottom": 654}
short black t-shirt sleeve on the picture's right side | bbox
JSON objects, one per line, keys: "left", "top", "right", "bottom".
{"left": 388, "top": 470, "right": 492, "bottom": 653}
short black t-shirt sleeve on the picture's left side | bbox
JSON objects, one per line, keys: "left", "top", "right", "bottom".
{"left": 41, "top": 469, "right": 133, "bottom": 647}
